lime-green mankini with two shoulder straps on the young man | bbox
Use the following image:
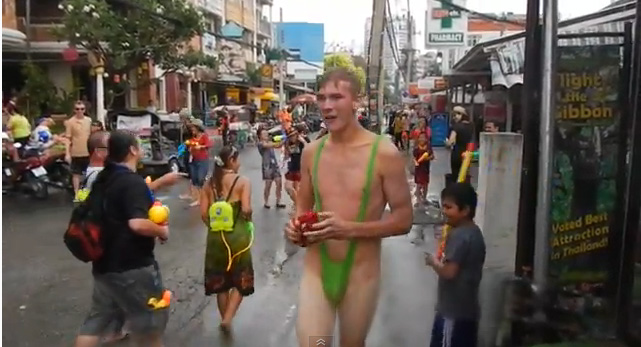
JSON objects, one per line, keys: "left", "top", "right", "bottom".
{"left": 312, "top": 135, "right": 382, "bottom": 306}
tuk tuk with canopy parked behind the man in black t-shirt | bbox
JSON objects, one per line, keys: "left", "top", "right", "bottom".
{"left": 105, "top": 110, "right": 187, "bottom": 178}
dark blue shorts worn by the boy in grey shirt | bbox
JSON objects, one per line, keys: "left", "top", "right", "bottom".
{"left": 430, "top": 312, "right": 479, "bottom": 347}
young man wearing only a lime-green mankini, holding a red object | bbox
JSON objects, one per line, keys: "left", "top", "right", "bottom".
{"left": 285, "top": 69, "right": 412, "bottom": 347}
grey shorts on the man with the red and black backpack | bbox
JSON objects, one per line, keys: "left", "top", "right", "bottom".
{"left": 79, "top": 266, "right": 169, "bottom": 336}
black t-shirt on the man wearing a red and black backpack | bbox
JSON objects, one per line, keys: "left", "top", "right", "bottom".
{"left": 93, "top": 167, "right": 156, "bottom": 273}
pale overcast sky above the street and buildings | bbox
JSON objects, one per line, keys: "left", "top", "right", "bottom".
{"left": 273, "top": 0, "right": 611, "bottom": 50}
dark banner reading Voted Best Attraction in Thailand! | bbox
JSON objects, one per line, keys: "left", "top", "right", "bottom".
{"left": 549, "top": 45, "right": 624, "bottom": 286}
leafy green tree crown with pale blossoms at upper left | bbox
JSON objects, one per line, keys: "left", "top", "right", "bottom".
{"left": 56, "top": 0, "right": 216, "bottom": 86}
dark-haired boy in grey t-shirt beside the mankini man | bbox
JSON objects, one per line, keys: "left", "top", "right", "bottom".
{"left": 425, "top": 183, "right": 485, "bottom": 347}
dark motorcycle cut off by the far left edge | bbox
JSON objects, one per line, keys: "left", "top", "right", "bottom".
{"left": 2, "top": 143, "right": 49, "bottom": 200}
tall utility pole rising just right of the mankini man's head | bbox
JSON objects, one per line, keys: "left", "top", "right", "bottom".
{"left": 366, "top": 0, "right": 386, "bottom": 132}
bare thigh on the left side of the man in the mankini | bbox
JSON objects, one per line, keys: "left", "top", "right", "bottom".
{"left": 296, "top": 270, "right": 336, "bottom": 347}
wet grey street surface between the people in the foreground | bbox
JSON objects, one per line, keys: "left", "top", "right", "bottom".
{"left": 2, "top": 146, "right": 458, "bottom": 347}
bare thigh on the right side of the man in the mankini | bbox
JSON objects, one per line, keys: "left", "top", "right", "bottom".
{"left": 338, "top": 277, "right": 380, "bottom": 347}
